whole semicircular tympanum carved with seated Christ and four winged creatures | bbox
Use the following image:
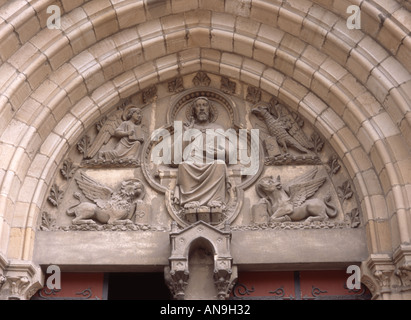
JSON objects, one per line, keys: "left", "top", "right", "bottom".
{"left": 40, "top": 72, "right": 361, "bottom": 231}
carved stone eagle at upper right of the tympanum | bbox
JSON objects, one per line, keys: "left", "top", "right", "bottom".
{"left": 251, "top": 98, "right": 314, "bottom": 153}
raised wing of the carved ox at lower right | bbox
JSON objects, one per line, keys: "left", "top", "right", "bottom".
{"left": 288, "top": 169, "right": 327, "bottom": 208}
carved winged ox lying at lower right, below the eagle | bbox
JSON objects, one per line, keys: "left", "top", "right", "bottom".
{"left": 256, "top": 169, "right": 338, "bottom": 223}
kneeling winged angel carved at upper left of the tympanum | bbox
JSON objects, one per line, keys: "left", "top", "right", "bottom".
{"left": 86, "top": 105, "right": 145, "bottom": 161}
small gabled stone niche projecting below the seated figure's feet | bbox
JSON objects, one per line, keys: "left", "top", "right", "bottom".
{"left": 165, "top": 221, "right": 237, "bottom": 300}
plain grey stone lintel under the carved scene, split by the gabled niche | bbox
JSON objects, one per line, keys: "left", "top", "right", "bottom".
{"left": 34, "top": 229, "right": 368, "bottom": 272}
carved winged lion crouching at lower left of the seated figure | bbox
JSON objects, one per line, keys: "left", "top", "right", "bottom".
{"left": 67, "top": 172, "right": 145, "bottom": 224}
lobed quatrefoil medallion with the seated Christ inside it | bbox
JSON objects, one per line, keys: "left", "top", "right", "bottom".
{"left": 141, "top": 88, "right": 264, "bottom": 227}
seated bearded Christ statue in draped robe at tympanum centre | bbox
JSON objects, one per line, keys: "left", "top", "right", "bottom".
{"left": 173, "top": 97, "right": 234, "bottom": 218}
